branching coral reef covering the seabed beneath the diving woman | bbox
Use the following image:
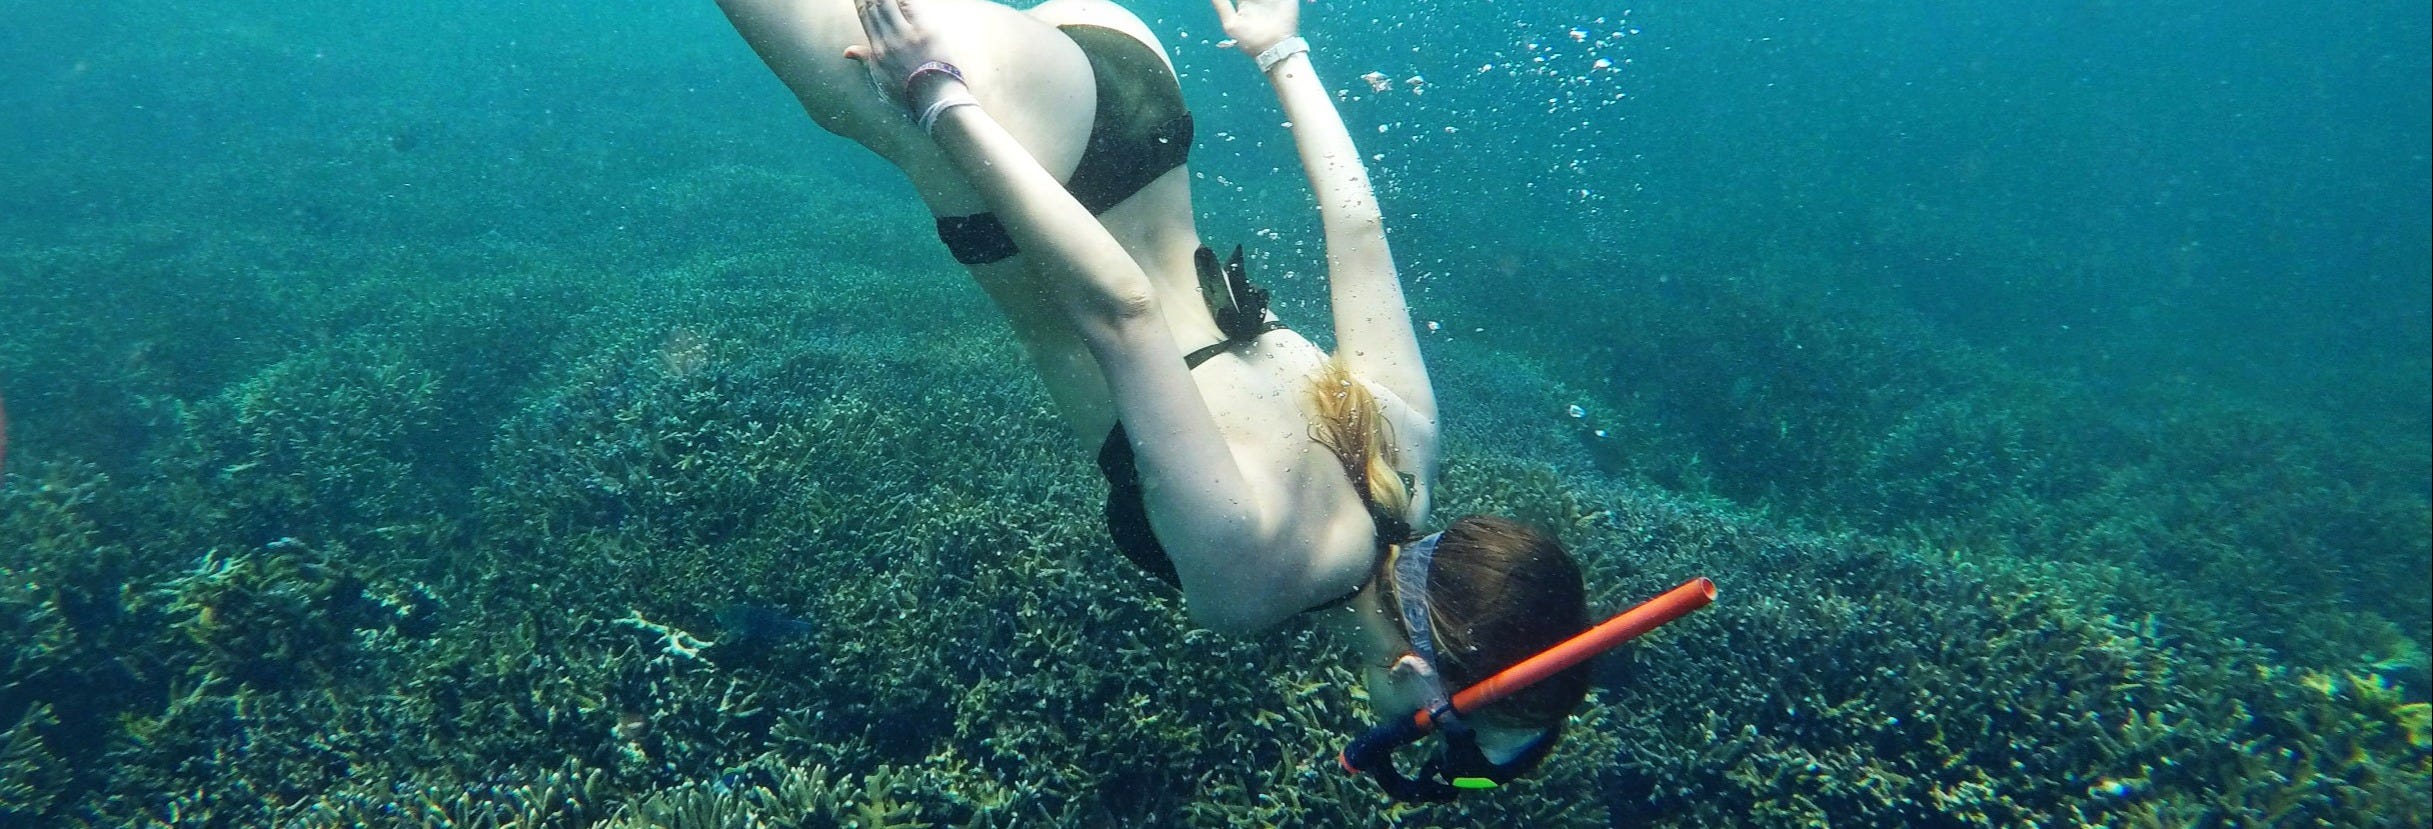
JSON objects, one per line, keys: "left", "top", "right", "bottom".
{"left": 0, "top": 202, "right": 2433, "bottom": 829}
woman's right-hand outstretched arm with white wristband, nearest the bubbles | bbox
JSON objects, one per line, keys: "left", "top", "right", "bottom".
{"left": 1209, "top": 0, "right": 1435, "bottom": 425}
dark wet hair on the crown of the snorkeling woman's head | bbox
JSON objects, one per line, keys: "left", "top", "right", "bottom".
{"left": 1380, "top": 515, "right": 1589, "bottom": 729}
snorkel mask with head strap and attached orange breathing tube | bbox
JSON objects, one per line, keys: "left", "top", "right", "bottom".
{"left": 1336, "top": 532, "right": 1715, "bottom": 802}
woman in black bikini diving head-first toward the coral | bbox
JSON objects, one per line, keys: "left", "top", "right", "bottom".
{"left": 720, "top": 0, "right": 1589, "bottom": 797}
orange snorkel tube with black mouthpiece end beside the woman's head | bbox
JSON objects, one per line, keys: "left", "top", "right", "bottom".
{"left": 1336, "top": 576, "right": 1715, "bottom": 800}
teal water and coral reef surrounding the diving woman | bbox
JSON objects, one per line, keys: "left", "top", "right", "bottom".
{"left": 0, "top": 0, "right": 2433, "bottom": 827}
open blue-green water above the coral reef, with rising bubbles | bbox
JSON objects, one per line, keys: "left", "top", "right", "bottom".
{"left": 0, "top": 2, "right": 2433, "bottom": 428}
